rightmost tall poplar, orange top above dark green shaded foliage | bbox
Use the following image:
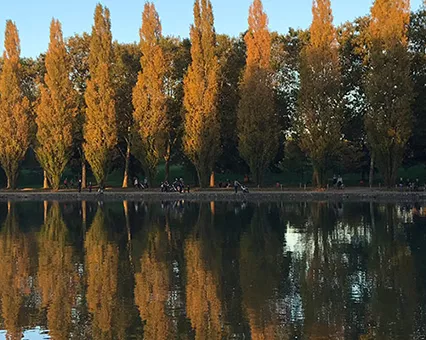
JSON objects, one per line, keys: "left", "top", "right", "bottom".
{"left": 365, "top": 0, "right": 412, "bottom": 186}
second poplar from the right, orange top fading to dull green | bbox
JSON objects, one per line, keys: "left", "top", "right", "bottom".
{"left": 296, "top": 0, "right": 343, "bottom": 187}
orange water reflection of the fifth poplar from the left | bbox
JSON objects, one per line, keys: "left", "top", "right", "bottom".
{"left": 184, "top": 204, "right": 223, "bottom": 339}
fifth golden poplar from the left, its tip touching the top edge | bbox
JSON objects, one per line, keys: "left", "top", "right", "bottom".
{"left": 183, "top": 0, "right": 220, "bottom": 187}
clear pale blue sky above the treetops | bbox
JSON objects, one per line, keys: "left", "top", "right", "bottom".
{"left": 0, "top": 0, "right": 422, "bottom": 57}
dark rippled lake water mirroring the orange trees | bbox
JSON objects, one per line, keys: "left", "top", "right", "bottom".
{"left": 0, "top": 202, "right": 426, "bottom": 340}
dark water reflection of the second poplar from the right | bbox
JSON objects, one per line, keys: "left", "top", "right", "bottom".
{"left": 301, "top": 202, "right": 348, "bottom": 339}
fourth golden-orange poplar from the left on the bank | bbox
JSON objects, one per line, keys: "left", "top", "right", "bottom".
{"left": 133, "top": 2, "right": 168, "bottom": 184}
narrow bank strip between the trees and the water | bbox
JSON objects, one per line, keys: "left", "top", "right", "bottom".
{"left": 0, "top": 188, "right": 426, "bottom": 203}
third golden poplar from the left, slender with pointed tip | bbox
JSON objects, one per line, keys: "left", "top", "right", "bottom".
{"left": 83, "top": 4, "right": 117, "bottom": 186}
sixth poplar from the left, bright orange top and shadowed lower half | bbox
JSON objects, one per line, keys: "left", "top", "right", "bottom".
{"left": 237, "top": 0, "right": 278, "bottom": 185}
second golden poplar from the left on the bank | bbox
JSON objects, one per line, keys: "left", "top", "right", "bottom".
{"left": 36, "top": 20, "right": 76, "bottom": 190}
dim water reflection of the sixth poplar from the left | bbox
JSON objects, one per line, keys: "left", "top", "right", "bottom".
{"left": 240, "top": 205, "right": 287, "bottom": 339}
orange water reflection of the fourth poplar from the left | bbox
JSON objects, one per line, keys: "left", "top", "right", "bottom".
{"left": 135, "top": 222, "right": 173, "bottom": 340}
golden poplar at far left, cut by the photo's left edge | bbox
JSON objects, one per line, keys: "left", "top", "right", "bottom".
{"left": 0, "top": 20, "right": 30, "bottom": 189}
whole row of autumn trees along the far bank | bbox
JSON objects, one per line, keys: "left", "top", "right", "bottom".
{"left": 0, "top": 0, "right": 420, "bottom": 189}
